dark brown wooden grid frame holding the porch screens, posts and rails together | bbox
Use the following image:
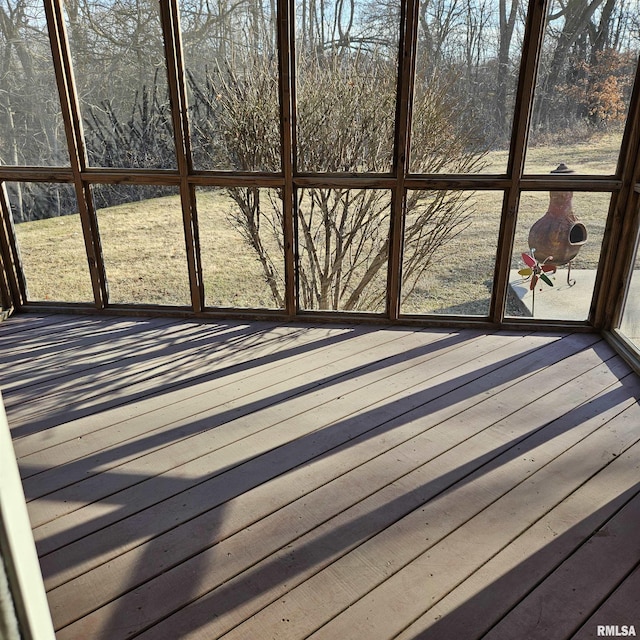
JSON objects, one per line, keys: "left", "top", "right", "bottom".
{"left": 0, "top": 0, "right": 640, "bottom": 344}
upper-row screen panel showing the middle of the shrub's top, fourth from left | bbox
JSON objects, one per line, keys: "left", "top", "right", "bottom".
{"left": 296, "top": 0, "right": 400, "bottom": 173}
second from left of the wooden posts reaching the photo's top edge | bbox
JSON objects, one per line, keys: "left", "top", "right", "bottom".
{"left": 160, "top": 0, "right": 204, "bottom": 312}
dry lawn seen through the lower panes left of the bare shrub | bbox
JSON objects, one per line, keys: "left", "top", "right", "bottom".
{"left": 16, "top": 191, "right": 274, "bottom": 307}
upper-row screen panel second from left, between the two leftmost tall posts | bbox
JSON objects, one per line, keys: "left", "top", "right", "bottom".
{"left": 63, "top": 0, "right": 176, "bottom": 169}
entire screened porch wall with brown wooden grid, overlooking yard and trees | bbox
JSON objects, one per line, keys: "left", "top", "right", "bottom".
{"left": 0, "top": 0, "right": 640, "bottom": 352}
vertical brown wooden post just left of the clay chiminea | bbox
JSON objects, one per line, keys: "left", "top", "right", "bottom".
{"left": 489, "top": 0, "right": 548, "bottom": 323}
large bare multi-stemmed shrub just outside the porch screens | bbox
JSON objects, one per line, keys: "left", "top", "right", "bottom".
{"left": 192, "top": 53, "right": 490, "bottom": 311}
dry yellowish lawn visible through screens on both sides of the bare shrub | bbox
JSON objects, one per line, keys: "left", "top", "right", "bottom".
{"left": 11, "top": 136, "right": 619, "bottom": 315}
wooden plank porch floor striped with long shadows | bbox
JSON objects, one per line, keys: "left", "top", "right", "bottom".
{"left": 0, "top": 316, "right": 640, "bottom": 640}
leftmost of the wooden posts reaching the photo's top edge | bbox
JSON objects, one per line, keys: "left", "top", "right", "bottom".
{"left": 44, "top": 0, "right": 108, "bottom": 309}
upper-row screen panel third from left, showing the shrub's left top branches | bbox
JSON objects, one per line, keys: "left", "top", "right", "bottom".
{"left": 180, "top": 0, "right": 281, "bottom": 172}
